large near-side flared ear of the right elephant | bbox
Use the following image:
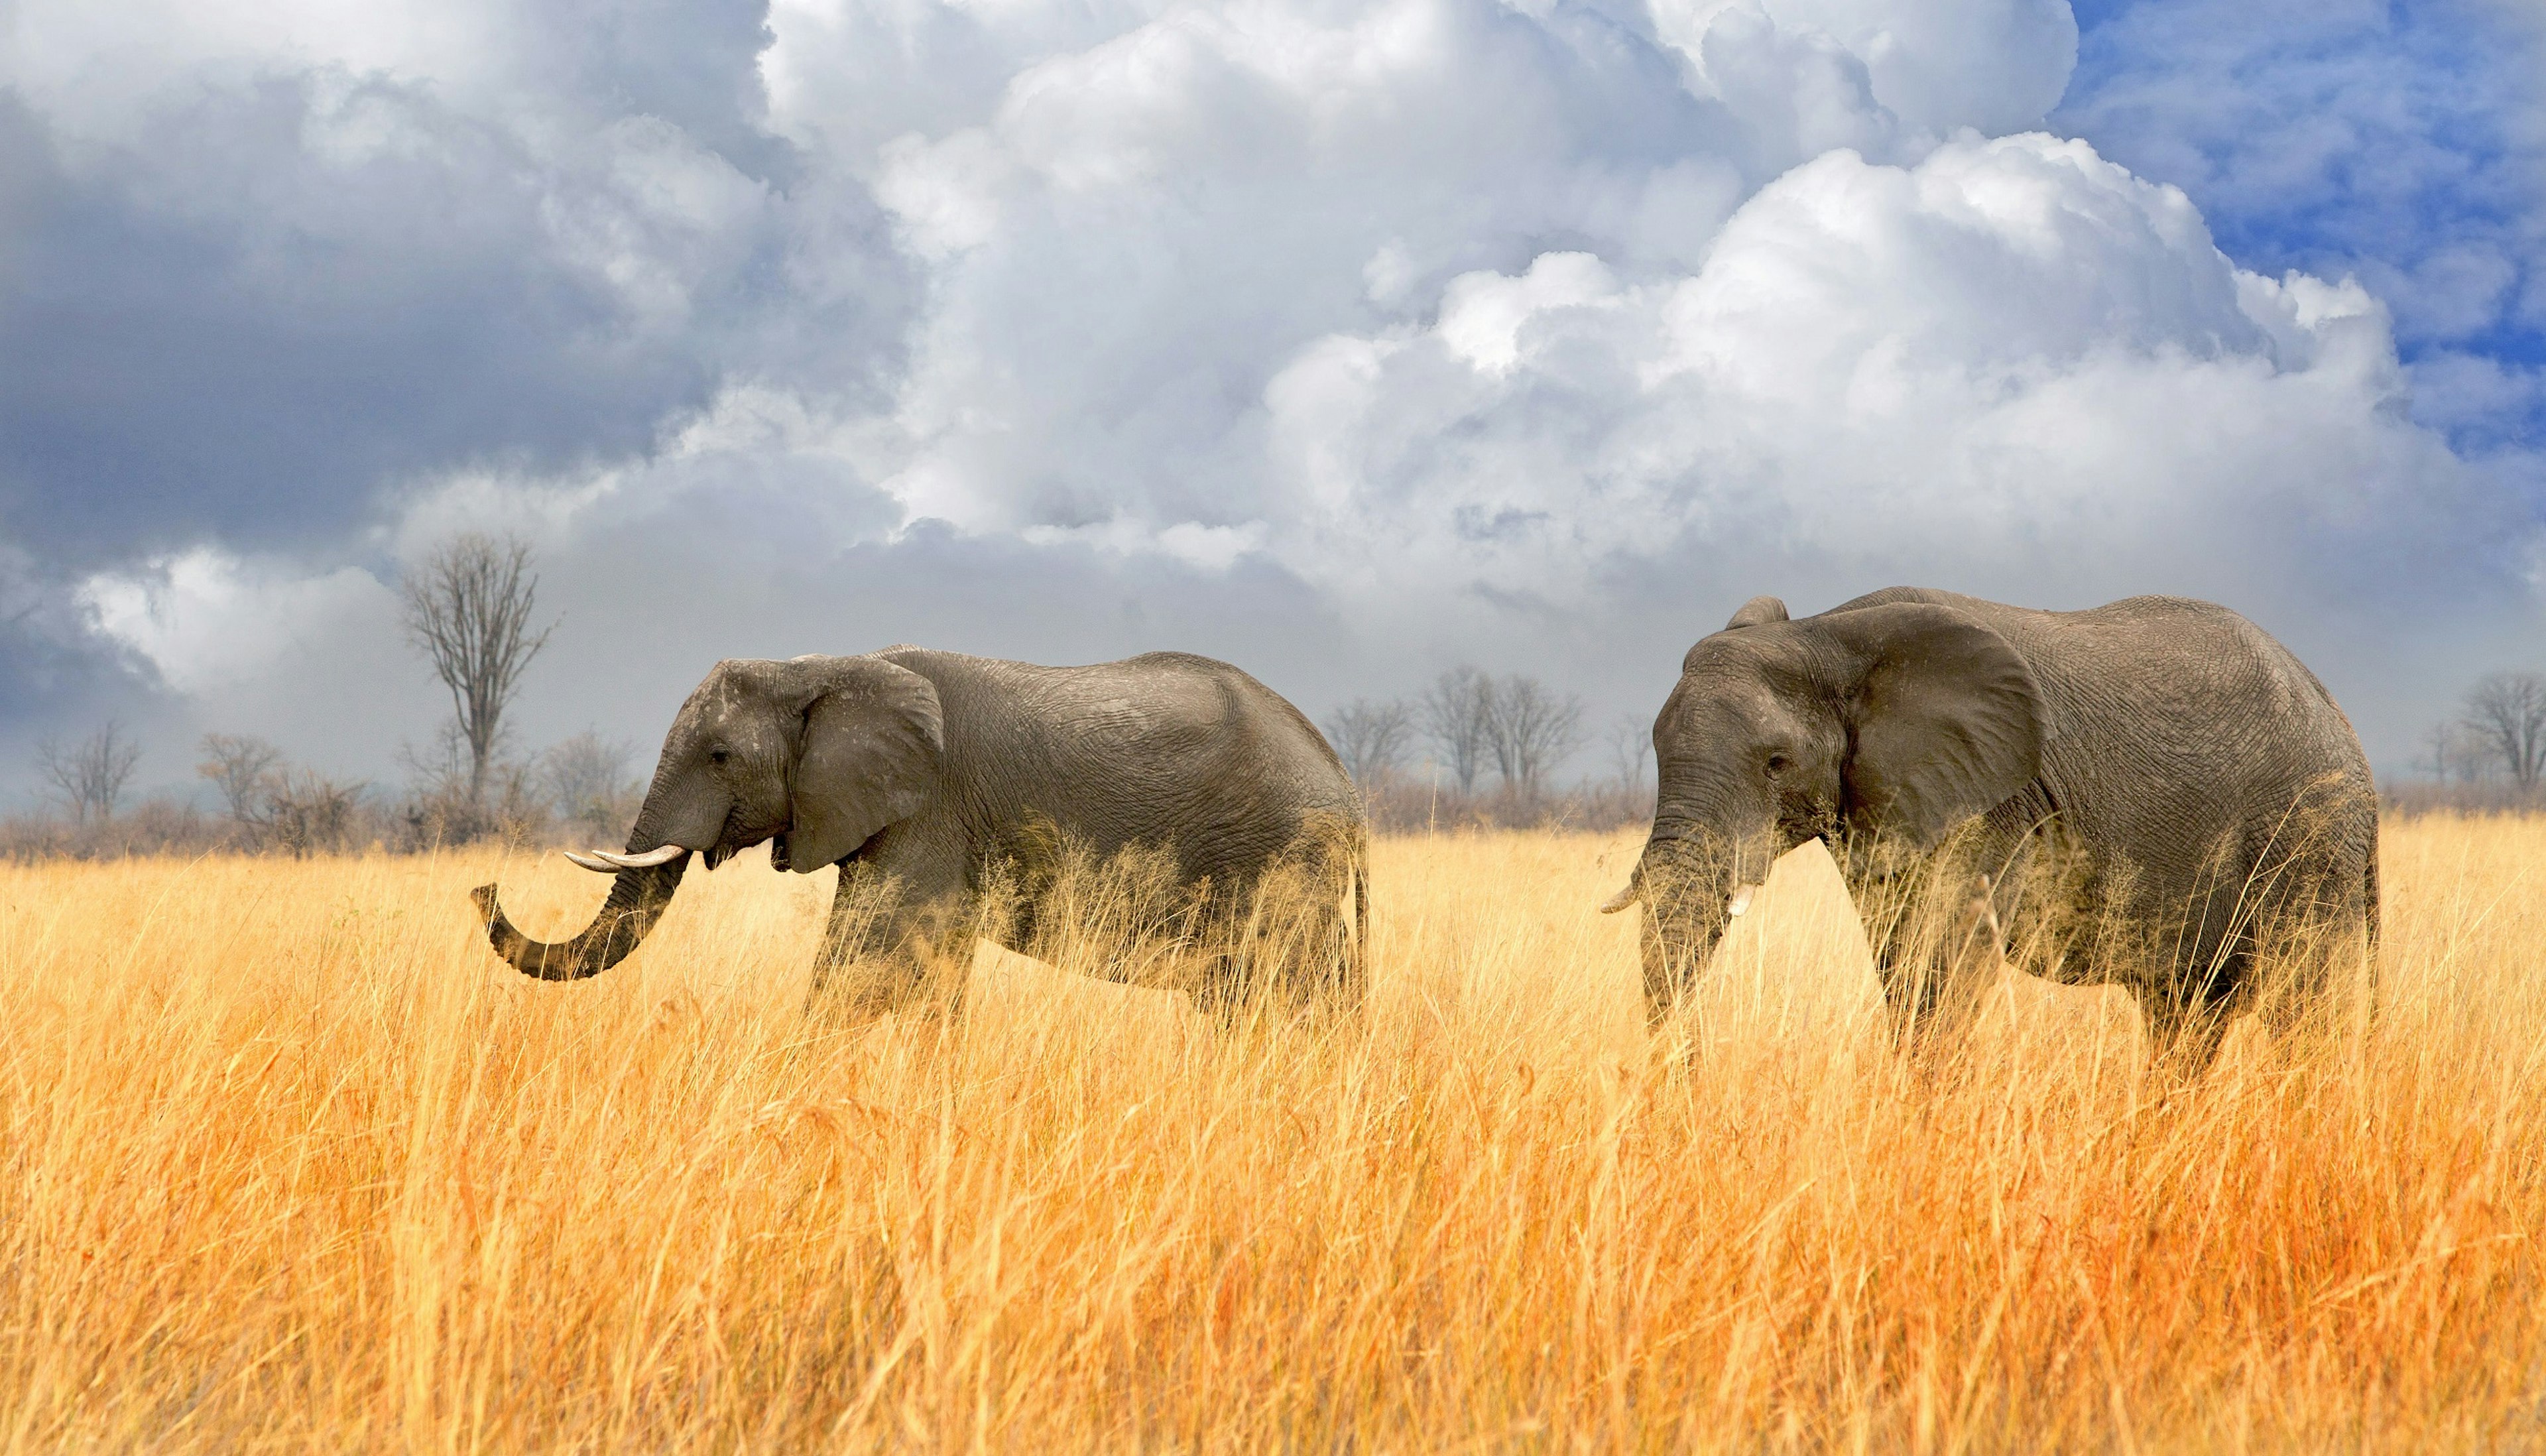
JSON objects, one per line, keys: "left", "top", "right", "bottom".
{"left": 1821, "top": 603, "right": 2042, "bottom": 847}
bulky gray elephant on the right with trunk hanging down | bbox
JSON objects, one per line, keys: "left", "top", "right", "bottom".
{"left": 1612, "top": 588, "right": 2378, "bottom": 1064}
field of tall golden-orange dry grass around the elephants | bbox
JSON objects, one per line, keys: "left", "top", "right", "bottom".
{"left": 0, "top": 817, "right": 2546, "bottom": 1451}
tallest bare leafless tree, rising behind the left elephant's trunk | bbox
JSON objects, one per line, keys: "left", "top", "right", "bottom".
{"left": 405, "top": 532, "right": 555, "bottom": 807}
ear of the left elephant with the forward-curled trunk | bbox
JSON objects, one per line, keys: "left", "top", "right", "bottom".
{"left": 787, "top": 657, "right": 945, "bottom": 873}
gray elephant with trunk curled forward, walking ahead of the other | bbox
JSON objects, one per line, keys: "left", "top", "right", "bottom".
{"left": 476, "top": 646, "right": 1364, "bottom": 1010}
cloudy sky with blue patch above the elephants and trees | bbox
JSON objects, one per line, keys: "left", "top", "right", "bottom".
{"left": 0, "top": 0, "right": 2546, "bottom": 807}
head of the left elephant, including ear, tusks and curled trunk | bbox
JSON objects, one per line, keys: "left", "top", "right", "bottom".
{"left": 473, "top": 657, "right": 945, "bottom": 980}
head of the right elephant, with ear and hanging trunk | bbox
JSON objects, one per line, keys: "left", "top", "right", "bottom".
{"left": 1601, "top": 595, "right": 2042, "bottom": 1013}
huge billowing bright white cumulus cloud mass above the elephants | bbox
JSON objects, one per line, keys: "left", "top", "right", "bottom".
{"left": 0, "top": 0, "right": 2536, "bottom": 789}
